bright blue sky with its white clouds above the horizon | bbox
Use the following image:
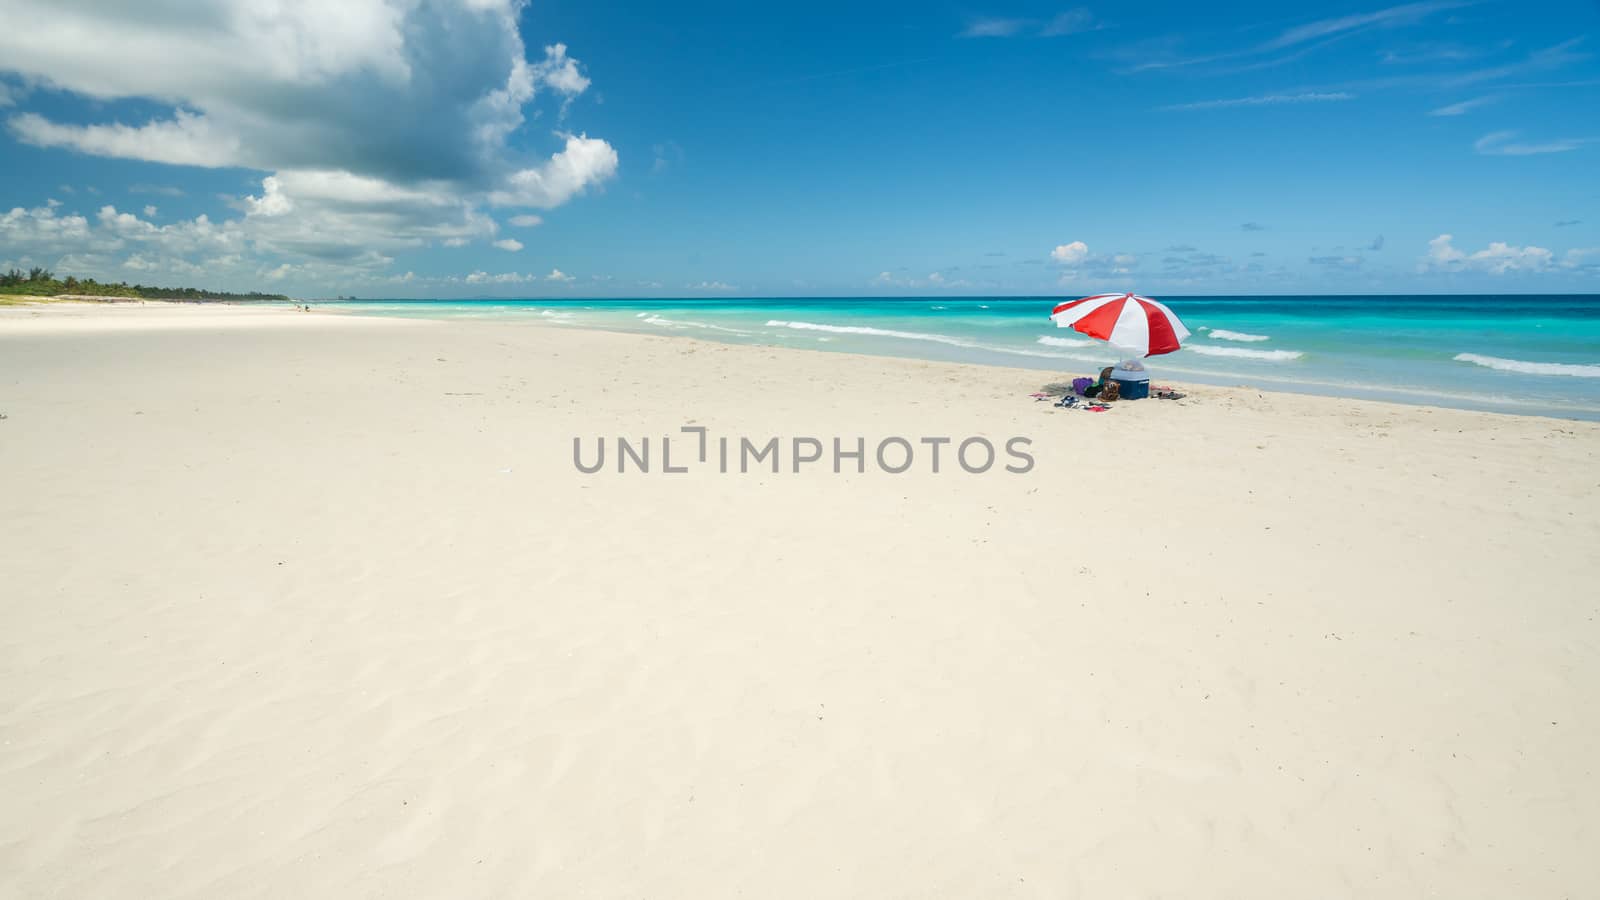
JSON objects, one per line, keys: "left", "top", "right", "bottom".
{"left": 0, "top": 0, "right": 1600, "bottom": 296}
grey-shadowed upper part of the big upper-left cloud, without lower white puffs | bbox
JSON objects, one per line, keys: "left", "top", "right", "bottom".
{"left": 0, "top": 0, "right": 470, "bottom": 176}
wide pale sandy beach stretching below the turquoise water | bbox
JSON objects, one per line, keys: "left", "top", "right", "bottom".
{"left": 0, "top": 304, "right": 1600, "bottom": 898}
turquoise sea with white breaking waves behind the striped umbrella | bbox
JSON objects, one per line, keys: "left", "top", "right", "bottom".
{"left": 318, "top": 295, "right": 1600, "bottom": 420}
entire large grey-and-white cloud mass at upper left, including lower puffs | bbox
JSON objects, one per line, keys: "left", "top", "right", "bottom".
{"left": 0, "top": 0, "right": 618, "bottom": 275}
